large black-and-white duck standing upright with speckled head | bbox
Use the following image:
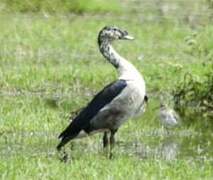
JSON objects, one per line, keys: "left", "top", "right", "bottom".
{"left": 57, "top": 26, "right": 148, "bottom": 155}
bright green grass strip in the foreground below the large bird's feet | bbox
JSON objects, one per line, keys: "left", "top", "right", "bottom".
{"left": 1, "top": 154, "right": 212, "bottom": 179}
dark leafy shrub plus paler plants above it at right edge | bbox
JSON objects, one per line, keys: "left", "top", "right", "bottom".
{"left": 173, "top": 26, "right": 213, "bottom": 127}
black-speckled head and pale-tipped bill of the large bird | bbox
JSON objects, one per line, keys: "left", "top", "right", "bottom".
{"left": 98, "top": 26, "right": 134, "bottom": 44}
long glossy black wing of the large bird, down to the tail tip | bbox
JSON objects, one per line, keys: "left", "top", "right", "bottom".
{"left": 57, "top": 80, "right": 127, "bottom": 150}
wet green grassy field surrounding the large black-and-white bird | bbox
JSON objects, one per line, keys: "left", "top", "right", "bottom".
{"left": 0, "top": 0, "right": 213, "bottom": 179}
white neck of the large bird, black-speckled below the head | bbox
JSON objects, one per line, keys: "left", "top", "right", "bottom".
{"left": 99, "top": 41, "right": 143, "bottom": 80}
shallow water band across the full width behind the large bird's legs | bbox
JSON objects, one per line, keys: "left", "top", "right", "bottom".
{"left": 0, "top": 129, "right": 213, "bottom": 162}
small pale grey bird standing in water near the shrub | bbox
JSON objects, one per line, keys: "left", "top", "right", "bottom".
{"left": 159, "top": 103, "right": 180, "bottom": 130}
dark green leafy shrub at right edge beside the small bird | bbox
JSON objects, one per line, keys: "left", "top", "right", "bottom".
{"left": 174, "top": 65, "right": 213, "bottom": 127}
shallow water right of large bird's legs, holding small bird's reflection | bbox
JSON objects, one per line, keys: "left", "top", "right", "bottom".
{"left": 119, "top": 131, "right": 213, "bottom": 161}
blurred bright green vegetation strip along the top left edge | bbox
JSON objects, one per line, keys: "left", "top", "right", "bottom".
{"left": 0, "top": 0, "right": 120, "bottom": 13}
